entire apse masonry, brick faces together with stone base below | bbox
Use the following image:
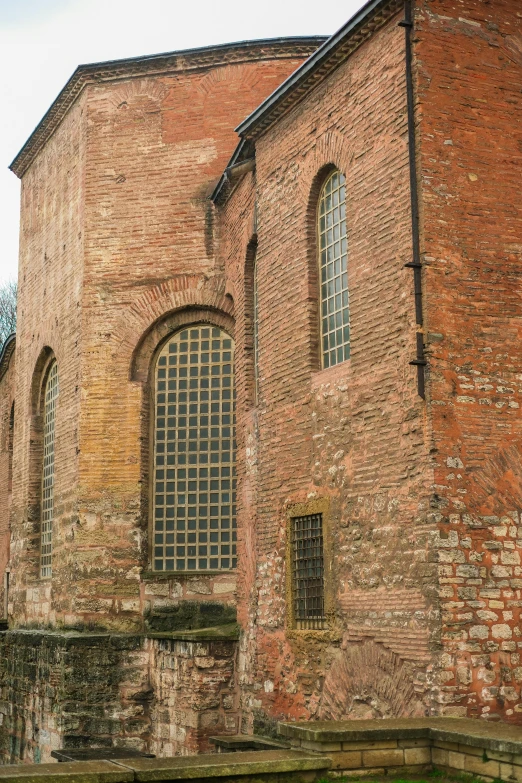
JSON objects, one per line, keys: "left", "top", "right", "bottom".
{"left": 0, "top": 41, "right": 314, "bottom": 760}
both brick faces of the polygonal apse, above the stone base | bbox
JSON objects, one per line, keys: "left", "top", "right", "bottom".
{"left": 8, "top": 42, "right": 313, "bottom": 630}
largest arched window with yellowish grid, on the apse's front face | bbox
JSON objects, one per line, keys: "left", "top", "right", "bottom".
{"left": 152, "top": 324, "right": 236, "bottom": 571}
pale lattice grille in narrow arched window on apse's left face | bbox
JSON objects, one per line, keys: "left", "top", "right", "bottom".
{"left": 40, "top": 362, "right": 59, "bottom": 579}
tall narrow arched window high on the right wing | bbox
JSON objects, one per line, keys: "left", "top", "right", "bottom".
{"left": 317, "top": 170, "right": 350, "bottom": 367}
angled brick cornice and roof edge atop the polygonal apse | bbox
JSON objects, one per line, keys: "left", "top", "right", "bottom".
{"left": 9, "top": 35, "right": 326, "bottom": 178}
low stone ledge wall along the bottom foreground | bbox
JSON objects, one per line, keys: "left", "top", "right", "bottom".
{"left": 0, "top": 718, "right": 522, "bottom": 783}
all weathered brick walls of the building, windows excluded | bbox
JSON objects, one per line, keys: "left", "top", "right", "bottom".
{"left": 0, "top": 0, "right": 522, "bottom": 760}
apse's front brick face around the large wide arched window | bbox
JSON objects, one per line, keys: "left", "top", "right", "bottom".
{"left": 74, "top": 50, "right": 312, "bottom": 627}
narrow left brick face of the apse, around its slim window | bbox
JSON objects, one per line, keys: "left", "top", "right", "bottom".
{"left": 10, "top": 96, "right": 85, "bottom": 624}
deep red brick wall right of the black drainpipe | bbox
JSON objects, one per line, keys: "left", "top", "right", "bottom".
{"left": 415, "top": 0, "right": 522, "bottom": 722}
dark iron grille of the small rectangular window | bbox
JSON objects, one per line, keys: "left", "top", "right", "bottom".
{"left": 291, "top": 514, "right": 325, "bottom": 629}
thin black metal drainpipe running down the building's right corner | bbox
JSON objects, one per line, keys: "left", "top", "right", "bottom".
{"left": 399, "top": 0, "right": 426, "bottom": 400}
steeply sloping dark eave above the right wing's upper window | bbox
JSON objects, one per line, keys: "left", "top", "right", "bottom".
{"left": 236, "top": 0, "right": 404, "bottom": 138}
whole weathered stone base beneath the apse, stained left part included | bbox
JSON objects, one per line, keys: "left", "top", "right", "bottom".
{"left": 0, "top": 626, "right": 237, "bottom": 764}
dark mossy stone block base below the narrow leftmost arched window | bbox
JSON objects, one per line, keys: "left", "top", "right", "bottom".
{"left": 0, "top": 631, "right": 151, "bottom": 764}
